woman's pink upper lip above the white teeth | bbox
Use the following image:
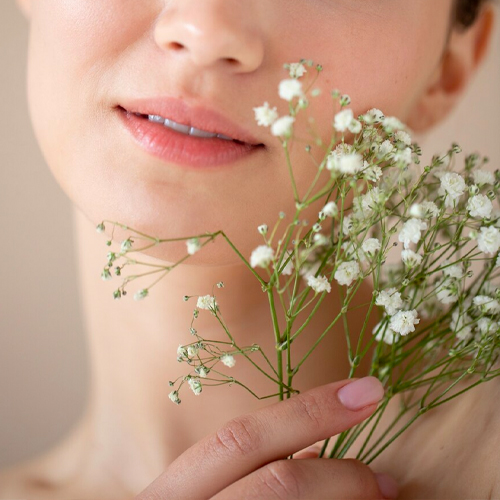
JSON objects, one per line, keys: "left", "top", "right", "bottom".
{"left": 120, "top": 97, "right": 263, "bottom": 146}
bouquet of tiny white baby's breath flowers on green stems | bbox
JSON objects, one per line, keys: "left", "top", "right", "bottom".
{"left": 97, "top": 59, "right": 500, "bottom": 463}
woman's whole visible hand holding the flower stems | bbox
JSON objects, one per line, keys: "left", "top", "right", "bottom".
{"left": 136, "top": 377, "right": 397, "bottom": 500}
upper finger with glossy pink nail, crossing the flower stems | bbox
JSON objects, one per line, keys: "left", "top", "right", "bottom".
{"left": 136, "top": 377, "right": 384, "bottom": 500}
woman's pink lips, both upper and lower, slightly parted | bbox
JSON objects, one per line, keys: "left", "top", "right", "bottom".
{"left": 116, "top": 98, "right": 265, "bottom": 168}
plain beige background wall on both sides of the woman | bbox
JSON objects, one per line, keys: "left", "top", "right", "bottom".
{"left": 0, "top": 0, "right": 500, "bottom": 467}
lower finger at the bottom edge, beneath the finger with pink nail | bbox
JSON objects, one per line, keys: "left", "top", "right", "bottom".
{"left": 211, "top": 459, "right": 396, "bottom": 500}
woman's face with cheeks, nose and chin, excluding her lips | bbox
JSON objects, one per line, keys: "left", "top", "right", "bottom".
{"left": 22, "top": 0, "right": 452, "bottom": 265}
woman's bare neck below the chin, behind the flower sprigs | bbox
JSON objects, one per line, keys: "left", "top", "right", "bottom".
{"left": 56, "top": 205, "right": 373, "bottom": 492}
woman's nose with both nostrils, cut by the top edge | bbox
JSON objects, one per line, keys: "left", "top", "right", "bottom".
{"left": 155, "top": 0, "right": 264, "bottom": 71}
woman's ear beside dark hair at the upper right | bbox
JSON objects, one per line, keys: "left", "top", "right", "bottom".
{"left": 406, "top": 2, "right": 495, "bottom": 133}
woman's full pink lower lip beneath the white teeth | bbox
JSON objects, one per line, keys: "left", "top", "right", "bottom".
{"left": 117, "top": 108, "right": 264, "bottom": 168}
